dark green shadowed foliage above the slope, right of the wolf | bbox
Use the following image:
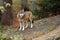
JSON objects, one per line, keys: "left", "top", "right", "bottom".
{"left": 32, "top": 0, "right": 60, "bottom": 18}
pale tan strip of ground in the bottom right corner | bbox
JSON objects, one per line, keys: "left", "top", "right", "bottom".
{"left": 33, "top": 25, "right": 60, "bottom": 40}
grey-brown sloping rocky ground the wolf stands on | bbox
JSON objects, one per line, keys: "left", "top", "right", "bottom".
{"left": 0, "top": 15, "right": 60, "bottom": 40}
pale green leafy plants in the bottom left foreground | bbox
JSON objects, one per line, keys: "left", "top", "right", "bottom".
{"left": 0, "top": 34, "right": 23, "bottom": 40}
